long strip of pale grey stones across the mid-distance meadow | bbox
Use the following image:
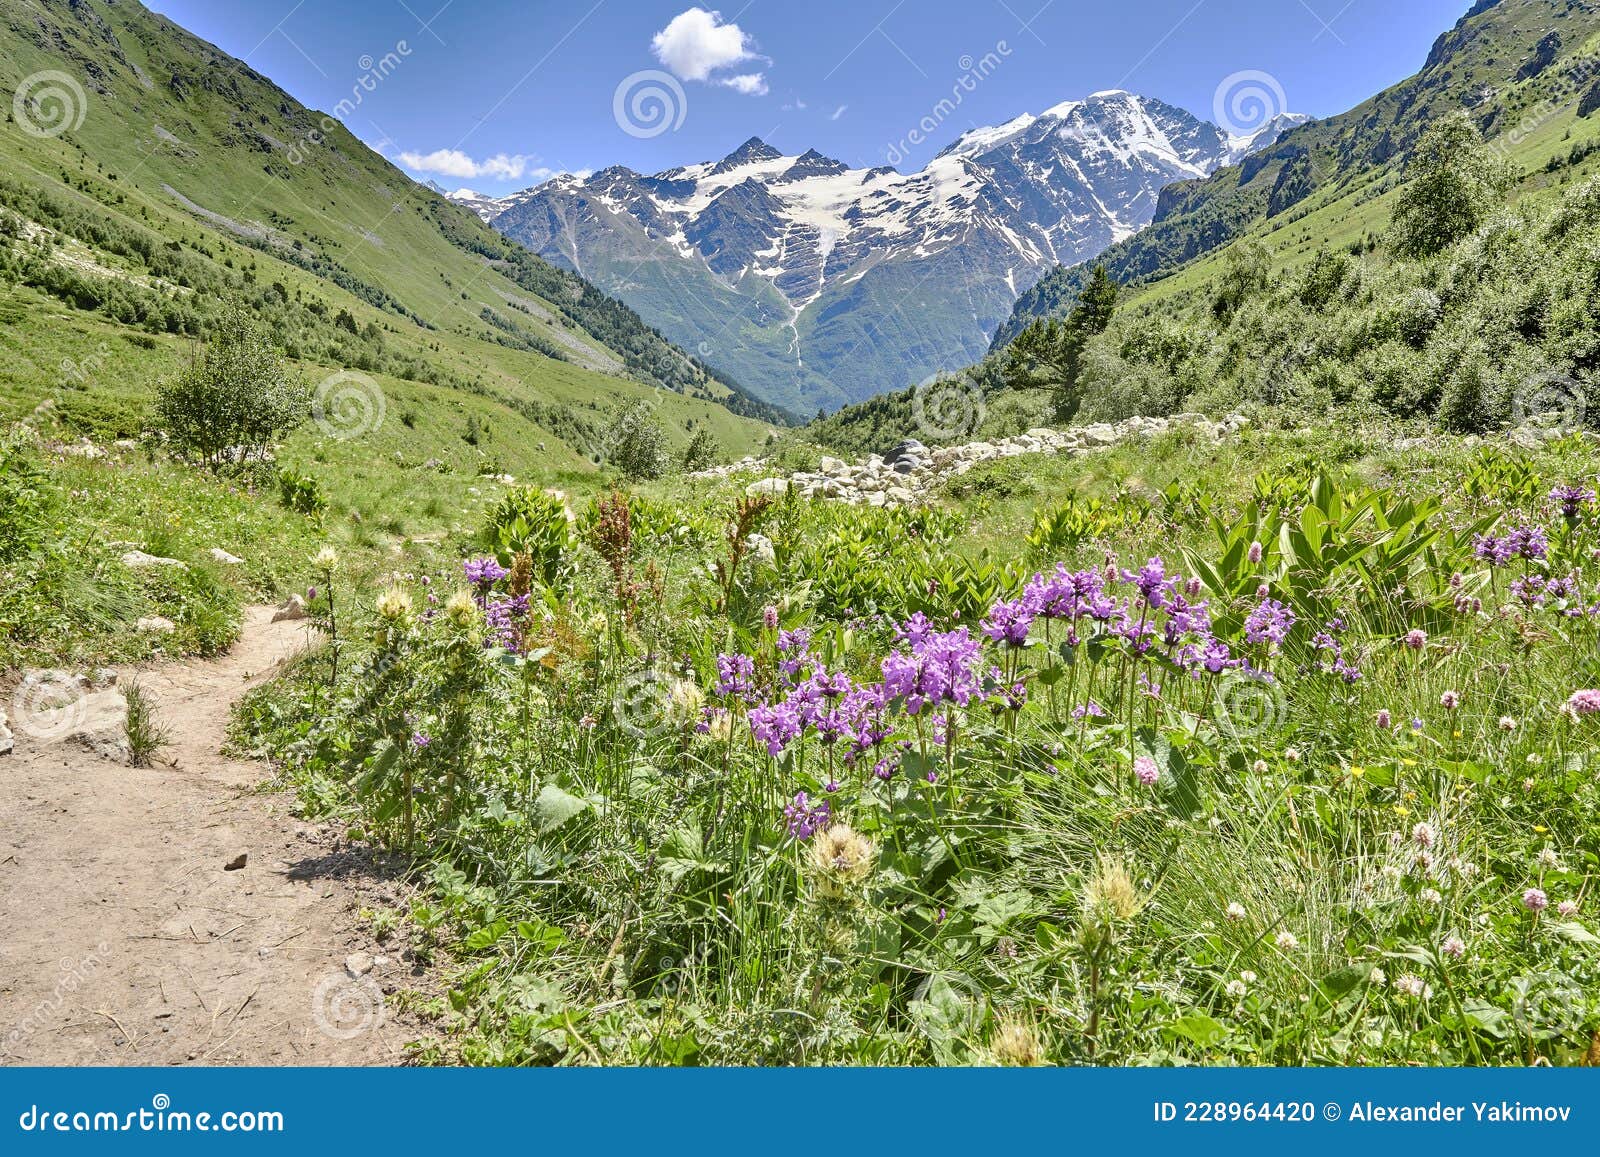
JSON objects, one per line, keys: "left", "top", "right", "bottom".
{"left": 736, "top": 414, "right": 1250, "bottom": 506}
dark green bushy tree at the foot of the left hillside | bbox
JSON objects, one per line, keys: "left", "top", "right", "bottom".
{"left": 155, "top": 306, "right": 310, "bottom": 470}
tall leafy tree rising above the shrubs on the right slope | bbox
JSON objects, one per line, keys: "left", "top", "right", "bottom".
{"left": 1390, "top": 112, "right": 1514, "bottom": 258}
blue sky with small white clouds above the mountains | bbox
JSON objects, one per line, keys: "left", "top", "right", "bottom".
{"left": 147, "top": 0, "right": 1469, "bottom": 194}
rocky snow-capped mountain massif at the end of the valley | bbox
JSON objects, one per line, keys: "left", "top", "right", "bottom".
{"left": 467, "top": 91, "right": 1298, "bottom": 413}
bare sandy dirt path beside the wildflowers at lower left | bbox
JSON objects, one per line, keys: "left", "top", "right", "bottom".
{"left": 0, "top": 608, "right": 419, "bottom": 1064}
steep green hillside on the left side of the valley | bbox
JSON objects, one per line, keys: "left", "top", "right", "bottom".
{"left": 0, "top": 0, "right": 779, "bottom": 451}
